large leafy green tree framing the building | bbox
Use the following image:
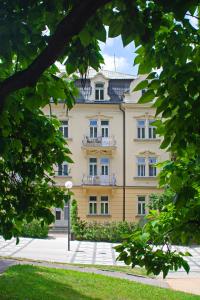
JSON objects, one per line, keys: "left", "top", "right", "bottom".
{"left": 0, "top": 0, "right": 200, "bottom": 275}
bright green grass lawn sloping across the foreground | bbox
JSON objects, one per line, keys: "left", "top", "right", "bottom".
{"left": 0, "top": 265, "right": 199, "bottom": 300}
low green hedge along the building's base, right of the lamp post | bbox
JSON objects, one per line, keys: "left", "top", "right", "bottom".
{"left": 73, "top": 219, "right": 136, "bottom": 242}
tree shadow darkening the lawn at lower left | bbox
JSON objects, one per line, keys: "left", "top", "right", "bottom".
{"left": 0, "top": 265, "right": 100, "bottom": 300}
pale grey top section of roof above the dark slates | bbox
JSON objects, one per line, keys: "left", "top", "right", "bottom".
{"left": 77, "top": 68, "right": 136, "bottom": 79}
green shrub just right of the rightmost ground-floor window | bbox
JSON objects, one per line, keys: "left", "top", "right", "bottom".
{"left": 148, "top": 188, "right": 175, "bottom": 211}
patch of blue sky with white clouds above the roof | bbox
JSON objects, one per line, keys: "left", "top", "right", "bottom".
{"left": 100, "top": 36, "right": 138, "bottom": 75}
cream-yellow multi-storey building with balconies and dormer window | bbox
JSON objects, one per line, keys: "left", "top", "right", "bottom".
{"left": 44, "top": 70, "right": 168, "bottom": 226}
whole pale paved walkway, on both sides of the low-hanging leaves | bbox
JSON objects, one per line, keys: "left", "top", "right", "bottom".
{"left": 0, "top": 235, "right": 200, "bottom": 295}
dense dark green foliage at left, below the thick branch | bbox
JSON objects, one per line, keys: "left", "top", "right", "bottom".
{"left": 0, "top": 101, "right": 71, "bottom": 239}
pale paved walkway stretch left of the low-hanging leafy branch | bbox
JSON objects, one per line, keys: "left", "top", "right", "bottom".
{"left": 0, "top": 236, "right": 124, "bottom": 265}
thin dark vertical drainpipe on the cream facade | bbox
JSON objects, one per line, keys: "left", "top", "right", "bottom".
{"left": 119, "top": 104, "right": 126, "bottom": 221}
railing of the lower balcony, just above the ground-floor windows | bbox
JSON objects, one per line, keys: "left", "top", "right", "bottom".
{"left": 82, "top": 174, "right": 116, "bottom": 186}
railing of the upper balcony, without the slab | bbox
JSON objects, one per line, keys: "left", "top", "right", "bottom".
{"left": 83, "top": 136, "right": 116, "bottom": 147}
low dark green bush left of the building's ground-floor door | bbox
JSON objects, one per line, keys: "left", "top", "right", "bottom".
{"left": 21, "top": 220, "right": 49, "bottom": 238}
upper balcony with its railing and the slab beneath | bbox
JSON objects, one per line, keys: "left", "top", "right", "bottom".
{"left": 82, "top": 136, "right": 116, "bottom": 154}
